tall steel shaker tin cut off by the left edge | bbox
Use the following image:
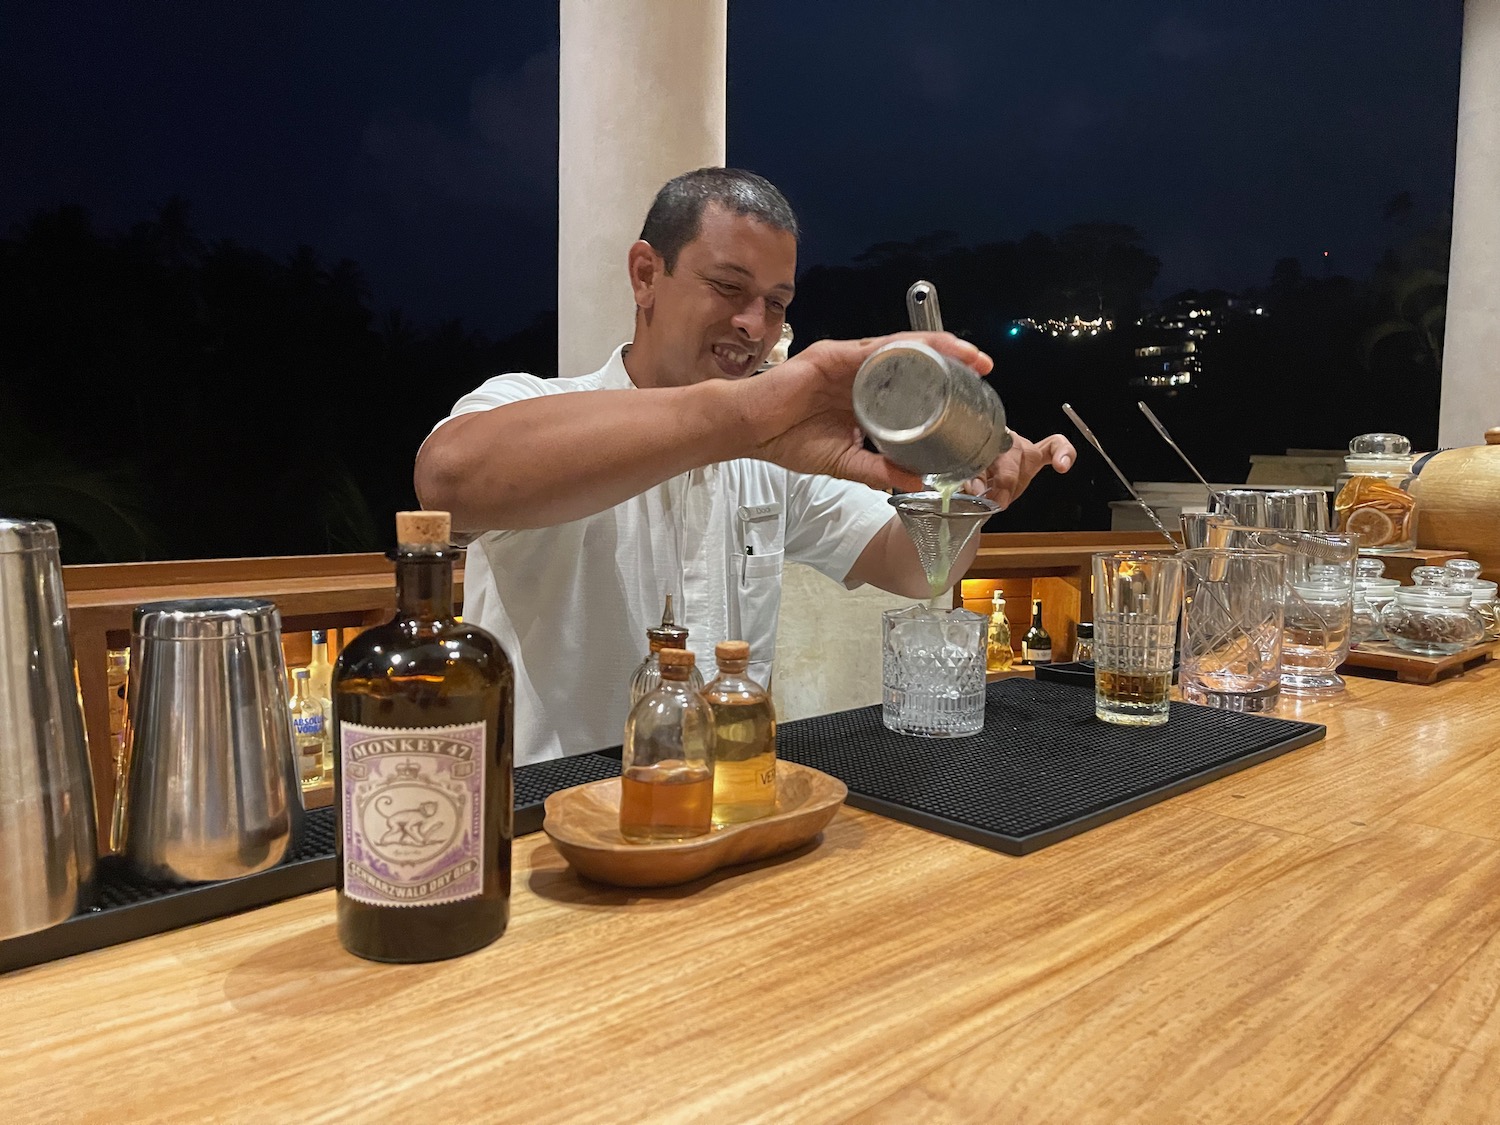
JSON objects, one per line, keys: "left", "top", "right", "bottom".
{"left": 0, "top": 518, "right": 96, "bottom": 939}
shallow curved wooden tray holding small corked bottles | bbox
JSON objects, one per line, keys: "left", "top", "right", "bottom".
{"left": 542, "top": 762, "right": 849, "bottom": 887}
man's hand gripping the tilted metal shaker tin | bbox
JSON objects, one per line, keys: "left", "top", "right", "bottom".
{"left": 734, "top": 332, "right": 995, "bottom": 492}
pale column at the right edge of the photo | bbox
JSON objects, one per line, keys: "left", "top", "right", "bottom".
{"left": 1437, "top": 0, "right": 1500, "bottom": 446}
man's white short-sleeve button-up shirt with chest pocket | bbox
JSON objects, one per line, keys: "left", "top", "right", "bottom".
{"left": 438, "top": 348, "right": 893, "bottom": 765}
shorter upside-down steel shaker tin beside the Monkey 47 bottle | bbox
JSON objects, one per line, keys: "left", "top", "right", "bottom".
{"left": 125, "top": 599, "right": 302, "bottom": 882}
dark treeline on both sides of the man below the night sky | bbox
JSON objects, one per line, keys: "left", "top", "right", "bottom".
{"left": 0, "top": 200, "right": 1448, "bottom": 563}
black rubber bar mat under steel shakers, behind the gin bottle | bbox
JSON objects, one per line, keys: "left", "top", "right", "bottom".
{"left": 0, "top": 752, "right": 620, "bottom": 974}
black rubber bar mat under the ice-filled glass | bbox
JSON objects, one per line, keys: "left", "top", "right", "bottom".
{"left": 777, "top": 678, "right": 1326, "bottom": 855}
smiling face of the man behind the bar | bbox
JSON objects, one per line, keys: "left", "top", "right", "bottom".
{"left": 638, "top": 204, "right": 797, "bottom": 386}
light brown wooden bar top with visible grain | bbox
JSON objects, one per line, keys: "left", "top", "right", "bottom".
{"left": 0, "top": 665, "right": 1500, "bottom": 1125}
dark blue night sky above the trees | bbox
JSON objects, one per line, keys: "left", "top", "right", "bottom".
{"left": 0, "top": 0, "right": 1461, "bottom": 335}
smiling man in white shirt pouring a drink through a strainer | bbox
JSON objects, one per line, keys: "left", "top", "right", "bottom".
{"left": 416, "top": 168, "right": 1076, "bottom": 765}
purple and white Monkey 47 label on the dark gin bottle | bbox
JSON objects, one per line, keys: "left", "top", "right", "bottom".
{"left": 339, "top": 722, "right": 485, "bottom": 906}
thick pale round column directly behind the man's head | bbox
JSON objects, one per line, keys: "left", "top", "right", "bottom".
{"left": 558, "top": 0, "right": 729, "bottom": 375}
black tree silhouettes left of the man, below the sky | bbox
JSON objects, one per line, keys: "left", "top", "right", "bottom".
{"left": 0, "top": 200, "right": 555, "bottom": 563}
